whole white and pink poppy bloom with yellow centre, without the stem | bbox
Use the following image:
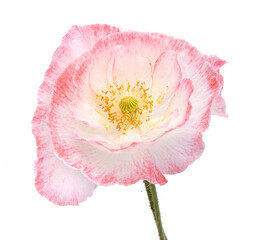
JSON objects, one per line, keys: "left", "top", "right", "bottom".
{"left": 32, "top": 25, "right": 226, "bottom": 205}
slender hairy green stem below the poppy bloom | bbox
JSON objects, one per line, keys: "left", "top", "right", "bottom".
{"left": 143, "top": 180, "right": 167, "bottom": 240}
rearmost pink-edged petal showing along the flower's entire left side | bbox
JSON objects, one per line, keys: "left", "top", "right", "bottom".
{"left": 32, "top": 25, "right": 119, "bottom": 205}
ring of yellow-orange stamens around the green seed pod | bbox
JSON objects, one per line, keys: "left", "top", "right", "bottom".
{"left": 96, "top": 78, "right": 163, "bottom": 135}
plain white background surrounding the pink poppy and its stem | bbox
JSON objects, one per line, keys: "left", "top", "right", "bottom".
{"left": 0, "top": 0, "right": 258, "bottom": 240}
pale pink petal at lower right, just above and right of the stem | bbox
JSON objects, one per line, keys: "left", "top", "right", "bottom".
{"left": 149, "top": 127, "right": 204, "bottom": 174}
